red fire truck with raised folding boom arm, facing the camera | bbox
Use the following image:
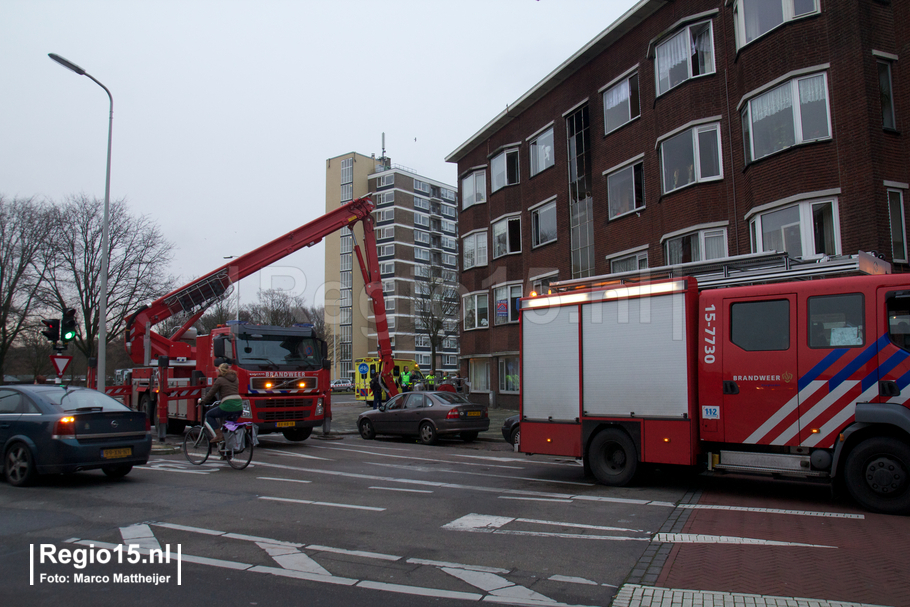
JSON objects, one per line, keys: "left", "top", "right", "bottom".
{"left": 101, "top": 197, "right": 397, "bottom": 441}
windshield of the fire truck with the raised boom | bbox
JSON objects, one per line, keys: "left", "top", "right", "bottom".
{"left": 236, "top": 333, "right": 322, "bottom": 371}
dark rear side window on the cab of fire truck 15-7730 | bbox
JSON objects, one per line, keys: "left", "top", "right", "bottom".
{"left": 730, "top": 299, "right": 790, "bottom": 352}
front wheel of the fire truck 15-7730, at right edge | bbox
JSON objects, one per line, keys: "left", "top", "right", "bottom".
{"left": 844, "top": 436, "right": 910, "bottom": 514}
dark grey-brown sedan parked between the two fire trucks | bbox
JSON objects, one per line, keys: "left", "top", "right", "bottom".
{"left": 357, "top": 392, "right": 490, "bottom": 445}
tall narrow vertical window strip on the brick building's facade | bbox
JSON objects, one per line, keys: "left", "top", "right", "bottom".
{"left": 566, "top": 104, "right": 594, "bottom": 278}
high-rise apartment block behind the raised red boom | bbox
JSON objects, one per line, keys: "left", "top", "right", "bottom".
{"left": 325, "top": 152, "right": 459, "bottom": 378}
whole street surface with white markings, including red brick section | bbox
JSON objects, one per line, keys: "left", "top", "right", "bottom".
{"left": 0, "top": 398, "right": 910, "bottom": 607}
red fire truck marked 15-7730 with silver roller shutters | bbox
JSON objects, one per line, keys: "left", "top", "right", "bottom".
{"left": 518, "top": 253, "right": 910, "bottom": 514}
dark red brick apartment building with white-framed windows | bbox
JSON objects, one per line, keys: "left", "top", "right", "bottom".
{"left": 446, "top": 0, "right": 910, "bottom": 408}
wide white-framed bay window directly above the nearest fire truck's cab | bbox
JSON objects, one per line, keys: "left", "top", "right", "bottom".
{"left": 750, "top": 200, "right": 840, "bottom": 259}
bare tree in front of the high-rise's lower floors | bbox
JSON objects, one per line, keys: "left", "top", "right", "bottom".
{"left": 411, "top": 275, "right": 459, "bottom": 375}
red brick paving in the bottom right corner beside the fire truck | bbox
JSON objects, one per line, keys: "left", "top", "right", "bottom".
{"left": 656, "top": 480, "right": 910, "bottom": 607}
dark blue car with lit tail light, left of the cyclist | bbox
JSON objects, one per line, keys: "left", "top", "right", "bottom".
{"left": 0, "top": 385, "right": 152, "bottom": 487}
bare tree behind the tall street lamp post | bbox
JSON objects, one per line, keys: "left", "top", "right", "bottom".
{"left": 42, "top": 195, "right": 173, "bottom": 356}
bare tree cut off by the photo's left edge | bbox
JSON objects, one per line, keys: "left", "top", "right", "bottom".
{"left": 0, "top": 195, "right": 54, "bottom": 378}
